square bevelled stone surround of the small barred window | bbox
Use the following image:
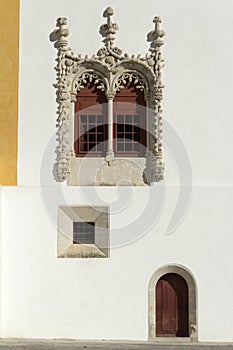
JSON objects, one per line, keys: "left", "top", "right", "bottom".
{"left": 57, "top": 206, "right": 109, "bottom": 258}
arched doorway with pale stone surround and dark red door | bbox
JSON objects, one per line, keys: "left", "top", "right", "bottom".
{"left": 148, "top": 264, "right": 198, "bottom": 342}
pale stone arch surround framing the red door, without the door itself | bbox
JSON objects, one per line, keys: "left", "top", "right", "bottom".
{"left": 148, "top": 264, "right": 198, "bottom": 341}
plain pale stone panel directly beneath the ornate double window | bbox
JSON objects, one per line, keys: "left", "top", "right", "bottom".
{"left": 68, "top": 157, "right": 146, "bottom": 186}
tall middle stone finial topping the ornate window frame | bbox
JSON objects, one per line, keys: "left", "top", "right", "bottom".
{"left": 100, "top": 7, "right": 119, "bottom": 49}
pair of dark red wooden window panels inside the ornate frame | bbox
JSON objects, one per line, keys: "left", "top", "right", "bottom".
{"left": 74, "top": 84, "right": 147, "bottom": 157}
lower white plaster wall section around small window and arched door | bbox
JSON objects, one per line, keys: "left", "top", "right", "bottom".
{"left": 2, "top": 187, "right": 233, "bottom": 341}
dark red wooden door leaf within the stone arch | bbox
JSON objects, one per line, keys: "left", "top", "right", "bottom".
{"left": 156, "top": 273, "right": 188, "bottom": 337}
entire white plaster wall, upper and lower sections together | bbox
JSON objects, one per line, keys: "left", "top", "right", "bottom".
{"left": 4, "top": 0, "right": 233, "bottom": 341}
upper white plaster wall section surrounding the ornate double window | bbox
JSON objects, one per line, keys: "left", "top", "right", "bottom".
{"left": 18, "top": 0, "right": 233, "bottom": 185}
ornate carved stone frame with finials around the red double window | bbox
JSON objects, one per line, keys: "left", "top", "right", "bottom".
{"left": 51, "top": 7, "right": 165, "bottom": 185}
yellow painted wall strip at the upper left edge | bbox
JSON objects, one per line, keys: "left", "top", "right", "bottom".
{"left": 0, "top": 0, "right": 19, "bottom": 186}
